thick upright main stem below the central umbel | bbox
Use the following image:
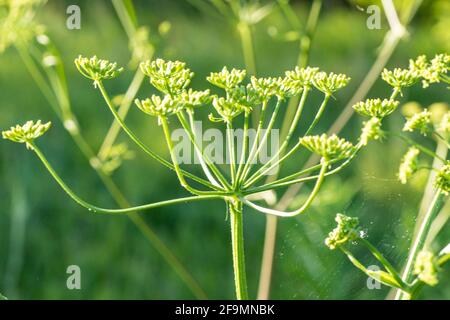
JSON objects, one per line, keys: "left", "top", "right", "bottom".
{"left": 228, "top": 201, "right": 248, "bottom": 300}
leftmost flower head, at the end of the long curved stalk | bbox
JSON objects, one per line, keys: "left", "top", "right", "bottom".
{"left": 2, "top": 120, "right": 51, "bottom": 148}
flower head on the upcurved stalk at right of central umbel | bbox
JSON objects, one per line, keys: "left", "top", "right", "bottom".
{"left": 300, "top": 133, "right": 355, "bottom": 160}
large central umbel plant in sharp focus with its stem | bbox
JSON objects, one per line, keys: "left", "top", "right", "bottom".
{"left": 2, "top": 56, "right": 390, "bottom": 299}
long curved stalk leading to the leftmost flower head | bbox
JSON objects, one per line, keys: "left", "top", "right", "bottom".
{"left": 28, "top": 142, "right": 223, "bottom": 214}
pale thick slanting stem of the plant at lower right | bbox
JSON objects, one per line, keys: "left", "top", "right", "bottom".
{"left": 395, "top": 190, "right": 444, "bottom": 300}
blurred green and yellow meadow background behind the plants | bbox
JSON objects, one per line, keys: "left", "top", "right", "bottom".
{"left": 0, "top": 0, "right": 450, "bottom": 299}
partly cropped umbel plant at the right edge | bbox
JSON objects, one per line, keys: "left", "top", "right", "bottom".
{"left": 325, "top": 54, "right": 450, "bottom": 299}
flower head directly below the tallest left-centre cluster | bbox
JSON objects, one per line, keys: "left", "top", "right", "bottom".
{"left": 134, "top": 95, "right": 183, "bottom": 117}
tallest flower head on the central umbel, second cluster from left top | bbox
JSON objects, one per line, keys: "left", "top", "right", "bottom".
{"left": 140, "top": 59, "right": 194, "bottom": 95}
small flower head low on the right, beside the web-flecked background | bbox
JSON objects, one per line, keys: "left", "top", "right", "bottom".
{"left": 325, "top": 213, "right": 359, "bottom": 250}
